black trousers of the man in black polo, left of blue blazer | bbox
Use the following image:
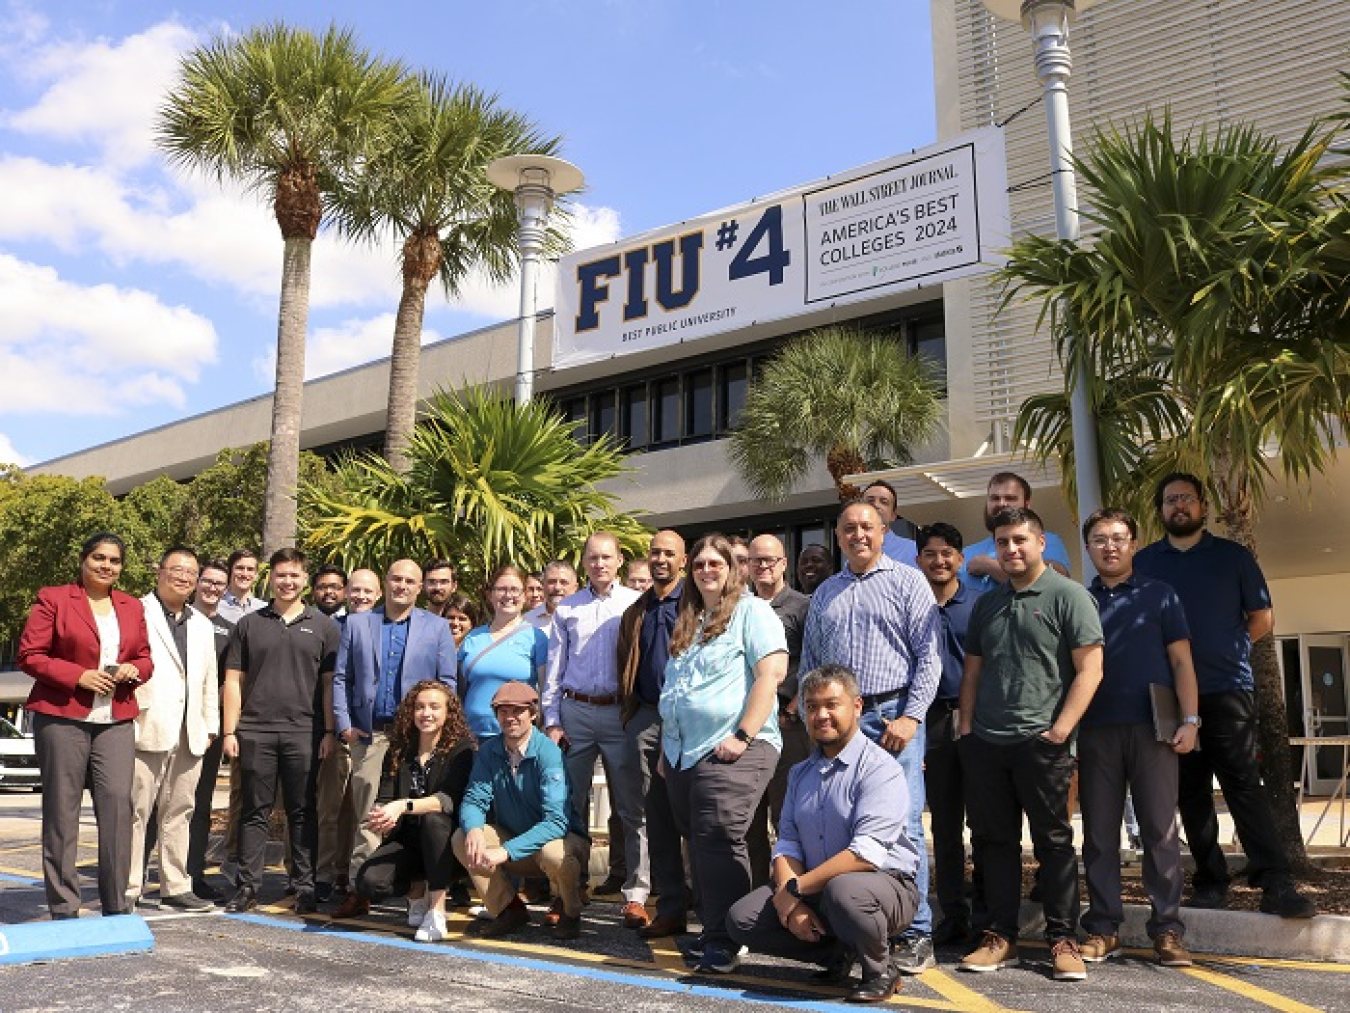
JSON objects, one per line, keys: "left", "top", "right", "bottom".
{"left": 238, "top": 729, "right": 319, "bottom": 893}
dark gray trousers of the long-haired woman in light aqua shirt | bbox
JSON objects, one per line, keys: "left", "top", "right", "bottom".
{"left": 666, "top": 739, "right": 778, "bottom": 945}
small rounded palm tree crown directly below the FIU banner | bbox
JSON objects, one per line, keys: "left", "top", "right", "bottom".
{"left": 728, "top": 327, "right": 942, "bottom": 501}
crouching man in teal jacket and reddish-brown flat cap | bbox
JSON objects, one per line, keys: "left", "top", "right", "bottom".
{"left": 452, "top": 682, "right": 590, "bottom": 939}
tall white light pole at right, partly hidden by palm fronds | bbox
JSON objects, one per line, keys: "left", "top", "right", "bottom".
{"left": 984, "top": 0, "right": 1102, "bottom": 540}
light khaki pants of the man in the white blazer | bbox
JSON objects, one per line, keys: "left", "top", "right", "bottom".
{"left": 127, "top": 729, "right": 201, "bottom": 906}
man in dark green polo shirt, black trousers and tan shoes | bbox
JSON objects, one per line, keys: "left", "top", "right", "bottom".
{"left": 959, "top": 508, "right": 1104, "bottom": 981}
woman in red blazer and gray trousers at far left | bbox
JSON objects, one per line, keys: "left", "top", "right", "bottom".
{"left": 19, "top": 532, "right": 153, "bottom": 918}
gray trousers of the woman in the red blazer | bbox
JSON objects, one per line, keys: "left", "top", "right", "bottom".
{"left": 32, "top": 715, "right": 136, "bottom": 918}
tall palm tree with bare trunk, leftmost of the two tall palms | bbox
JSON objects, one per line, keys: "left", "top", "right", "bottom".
{"left": 157, "top": 22, "right": 408, "bottom": 552}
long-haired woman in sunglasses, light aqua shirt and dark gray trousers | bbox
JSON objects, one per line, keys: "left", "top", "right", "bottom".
{"left": 660, "top": 535, "right": 787, "bottom": 974}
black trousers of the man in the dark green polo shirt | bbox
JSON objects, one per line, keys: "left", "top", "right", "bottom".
{"left": 960, "top": 735, "right": 1079, "bottom": 943}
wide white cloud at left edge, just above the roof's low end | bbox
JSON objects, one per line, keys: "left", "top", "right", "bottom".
{"left": 0, "top": 254, "right": 216, "bottom": 415}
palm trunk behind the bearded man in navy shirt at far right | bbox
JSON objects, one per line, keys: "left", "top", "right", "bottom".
{"left": 1215, "top": 470, "right": 1311, "bottom": 875}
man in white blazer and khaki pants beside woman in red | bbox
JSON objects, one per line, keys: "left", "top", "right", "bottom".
{"left": 127, "top": 546, "right": 220, "bottom": 910}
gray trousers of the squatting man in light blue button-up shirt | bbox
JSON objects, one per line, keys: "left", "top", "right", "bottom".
{"left": 726, "top": 871, "right": 919, "bottom": 981}
